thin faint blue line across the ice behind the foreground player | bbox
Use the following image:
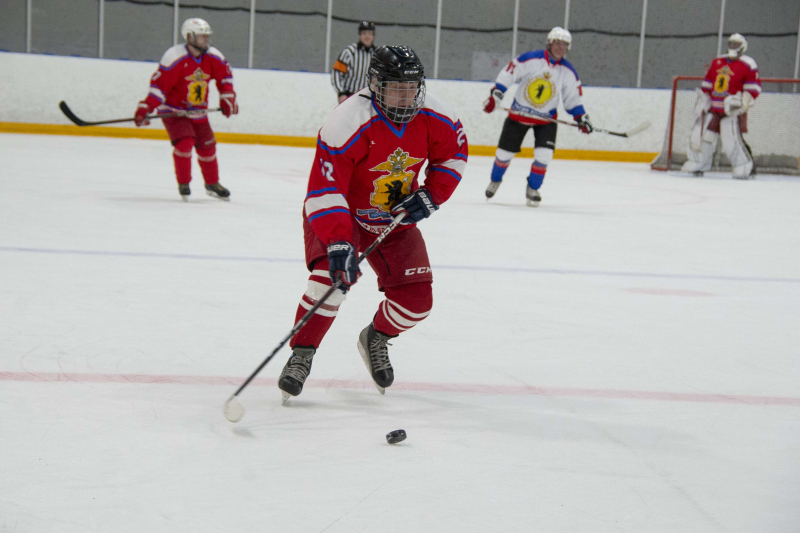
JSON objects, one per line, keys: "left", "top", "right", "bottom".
{"left": 0, "top": 246, "right": 800, "bottom": 283}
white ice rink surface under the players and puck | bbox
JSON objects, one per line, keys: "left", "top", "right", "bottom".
{"left": 0, "top": 134, "right": 800, "bottom": 533}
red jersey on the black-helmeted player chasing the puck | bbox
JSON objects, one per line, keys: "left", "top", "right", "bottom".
{"left": 304, "top": 89, "right": 467, "bottom": 244}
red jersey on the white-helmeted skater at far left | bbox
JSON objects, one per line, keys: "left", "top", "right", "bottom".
{"left": 145, "top": 44, "right": 233, "bottom": 120}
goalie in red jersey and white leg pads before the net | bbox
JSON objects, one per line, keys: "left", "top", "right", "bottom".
{"left": 681, "top": 33, "right": 761, "bottom": 179}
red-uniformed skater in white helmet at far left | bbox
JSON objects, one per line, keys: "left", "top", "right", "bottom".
{"left": 135, "top": 18, "right": 239, "bottom": 201}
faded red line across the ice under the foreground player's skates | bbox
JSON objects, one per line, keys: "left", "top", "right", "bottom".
{"left": 0, "top": 372, "right": 800, "bottom": 407}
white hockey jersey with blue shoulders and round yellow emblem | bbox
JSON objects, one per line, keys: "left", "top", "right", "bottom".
{"left": 495, "top": 50, "right": 586, "bottom": 124}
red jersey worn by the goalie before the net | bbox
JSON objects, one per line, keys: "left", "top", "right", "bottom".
{"left": 701, "top": 55, "right": 761, "bottom": 113}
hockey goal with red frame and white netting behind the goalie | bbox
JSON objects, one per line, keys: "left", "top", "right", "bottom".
{"left": 650, "top": 76, "right": 800, "bottom": 175}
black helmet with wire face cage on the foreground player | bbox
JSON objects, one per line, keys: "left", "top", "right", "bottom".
{"left": 369, "top": 46, "right": 425, "bottom": 124}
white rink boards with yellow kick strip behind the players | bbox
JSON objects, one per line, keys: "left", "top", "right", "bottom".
{"left": 0, "top": 53, "right": 670, "bottom": 161}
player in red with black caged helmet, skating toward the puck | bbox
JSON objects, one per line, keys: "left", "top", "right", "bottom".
{"left": 278, "top": 46, "right": 467, "bottom": 400}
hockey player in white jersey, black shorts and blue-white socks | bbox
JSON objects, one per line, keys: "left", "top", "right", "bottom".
{"left": 483, "top": 27, "right": 592, "bottom": 207}
